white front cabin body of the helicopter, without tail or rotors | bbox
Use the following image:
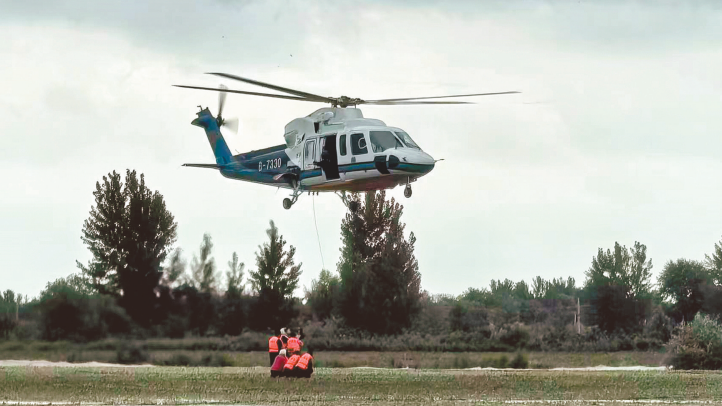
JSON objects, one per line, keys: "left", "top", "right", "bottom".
{"left": 284, "top": 107, "right": 435, "bottom": 192}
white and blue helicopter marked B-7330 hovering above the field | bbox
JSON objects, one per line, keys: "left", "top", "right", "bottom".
{"left": 173, "top": 72, "right": 520, "bottom": 211}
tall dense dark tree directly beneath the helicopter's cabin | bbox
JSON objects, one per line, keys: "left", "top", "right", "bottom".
{"left": 338, "top": 191, "right": 422, "bottom": 333}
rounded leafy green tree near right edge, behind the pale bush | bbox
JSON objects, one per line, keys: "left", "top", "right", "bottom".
{"left": 657, "top": 258, "right": 713, "bottom": 321}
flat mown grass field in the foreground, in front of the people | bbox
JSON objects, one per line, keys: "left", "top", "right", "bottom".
{"left": 0, "top": 367, "right": 722, "bottom": 405}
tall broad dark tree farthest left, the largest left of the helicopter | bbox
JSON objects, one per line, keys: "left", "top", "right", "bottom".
{"left": 78, "top": 170, "right": 177, "bottom": 324}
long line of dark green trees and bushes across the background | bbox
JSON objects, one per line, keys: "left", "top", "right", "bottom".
{"left": 0, "top": 170, "right": 722, "bottom": 356}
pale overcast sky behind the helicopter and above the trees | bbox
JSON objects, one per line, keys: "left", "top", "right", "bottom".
{"left": 0, "top": 0, "right": 722, "bottom": 297}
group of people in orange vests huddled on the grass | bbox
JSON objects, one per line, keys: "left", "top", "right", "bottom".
{"left": 268, "top": 328, "right": 313, "bottom": 378}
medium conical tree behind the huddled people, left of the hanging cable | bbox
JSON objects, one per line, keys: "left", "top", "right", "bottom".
{"left": 249, "top": 220, "right": 301, "bottom": 330}
